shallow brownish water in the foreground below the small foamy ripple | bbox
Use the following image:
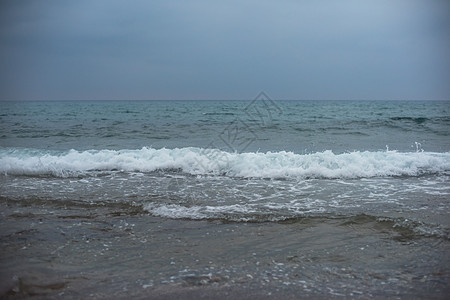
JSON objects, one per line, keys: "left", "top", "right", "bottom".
{"left": 1, "top": 199, "right": 450, "bottom": 299}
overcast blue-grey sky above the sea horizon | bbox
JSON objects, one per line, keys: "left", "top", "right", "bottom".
{"left": 0, "top": 0, "right": 450, "bottom": 100}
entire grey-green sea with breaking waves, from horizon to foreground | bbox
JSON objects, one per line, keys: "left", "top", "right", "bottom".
{"left": 0, "top": 98, "right": 450, "bottom": 299}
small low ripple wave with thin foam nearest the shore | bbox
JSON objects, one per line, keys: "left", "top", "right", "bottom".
{"left": 143, "top": 203, "right": 450, "bottom": 242}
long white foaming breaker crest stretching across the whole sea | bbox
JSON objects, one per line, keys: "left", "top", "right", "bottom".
{"left": 0, "top": 147, "right": 450, "bottom": 178}
